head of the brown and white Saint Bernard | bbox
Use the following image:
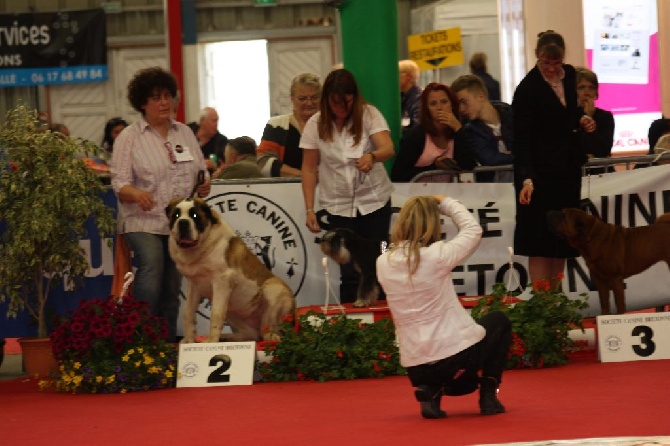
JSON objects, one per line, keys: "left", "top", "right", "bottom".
{"left": 165, "top": 198, "right": 219, "bottom": 249}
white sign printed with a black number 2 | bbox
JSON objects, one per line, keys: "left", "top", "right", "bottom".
{"left": 177, "top": 342, "right": 256, "bottom": 387}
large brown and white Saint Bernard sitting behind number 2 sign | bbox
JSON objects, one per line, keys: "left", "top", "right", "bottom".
{"left": 165, "top": 198, "right": 295, "bottom": 343}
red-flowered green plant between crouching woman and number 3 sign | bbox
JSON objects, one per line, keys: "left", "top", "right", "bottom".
{"left": 472, "top": 275, "right": 588, "bottom": 368}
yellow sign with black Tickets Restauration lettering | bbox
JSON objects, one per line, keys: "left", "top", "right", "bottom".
{"left": 407, "top": 28, "right": 463, "bottom": 70}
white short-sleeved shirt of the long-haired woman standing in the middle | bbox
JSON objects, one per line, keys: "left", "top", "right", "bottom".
{"left": 300, "top": 104, "right": 393, "bottom": 217}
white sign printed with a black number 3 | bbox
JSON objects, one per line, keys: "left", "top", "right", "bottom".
{"left": 596, "top": 312, "right": 670, "bottom": 362}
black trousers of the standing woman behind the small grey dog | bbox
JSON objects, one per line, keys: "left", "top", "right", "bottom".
{"left": 328, "top": 200, "right": 391, "bottom": 303}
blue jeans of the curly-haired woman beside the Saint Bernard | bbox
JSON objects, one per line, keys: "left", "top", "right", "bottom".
{"left": 124, "top": 232, "right": 181, "bottom": 342}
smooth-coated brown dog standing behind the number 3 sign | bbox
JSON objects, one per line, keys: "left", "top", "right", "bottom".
{"left": 547, "top": 208, "right": 670, "bottom": 314}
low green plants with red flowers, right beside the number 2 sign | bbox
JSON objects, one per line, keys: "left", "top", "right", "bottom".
{"left": 257, "top": 311, "right": 405, "bottom": 381}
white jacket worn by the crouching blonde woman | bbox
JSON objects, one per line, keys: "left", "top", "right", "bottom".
{"left": 377, "top": 198, "right": 485, "bottom": 367}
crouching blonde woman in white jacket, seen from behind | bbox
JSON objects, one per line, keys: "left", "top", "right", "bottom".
{"left": 377, "top": 195, "right": 512, "bottom": 418}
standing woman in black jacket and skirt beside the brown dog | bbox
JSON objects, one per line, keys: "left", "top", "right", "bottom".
{"left": 512, "top": 31, "right": 596, "bottom": 286}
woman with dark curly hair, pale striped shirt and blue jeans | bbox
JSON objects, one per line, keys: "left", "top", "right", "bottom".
{"left": 111, "top": 67, "right": 210, "bottom": 341}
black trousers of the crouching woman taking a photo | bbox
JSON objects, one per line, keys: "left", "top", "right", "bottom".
{"left": 407, "top": 311, "right": 512, "bottom": 395}
